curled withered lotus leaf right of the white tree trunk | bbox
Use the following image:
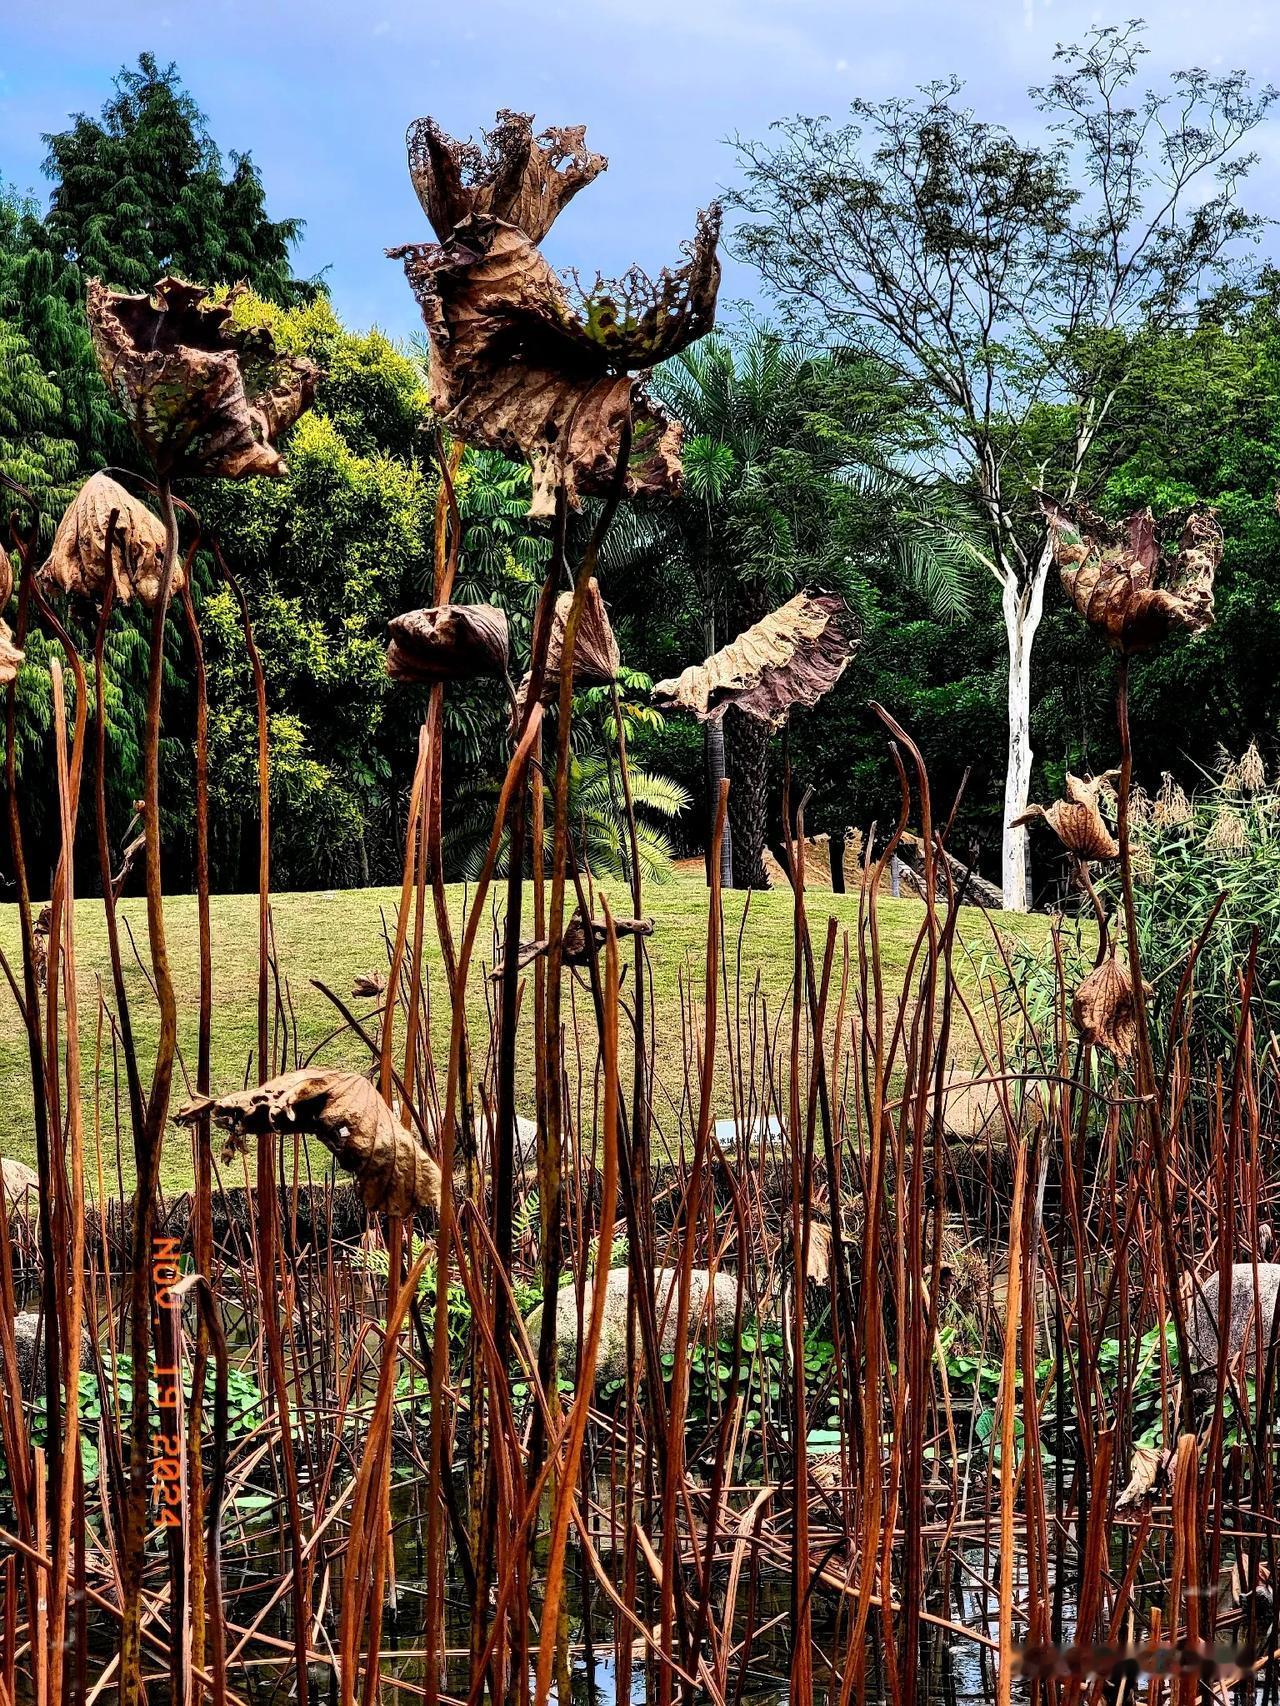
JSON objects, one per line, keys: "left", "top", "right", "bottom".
{"left": 1039, "top": 496, "right": 1222, "bottom": 652}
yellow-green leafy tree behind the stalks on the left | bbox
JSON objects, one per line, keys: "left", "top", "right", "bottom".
{"left": 193, "top": 295, "right": 435, "bottom": 887}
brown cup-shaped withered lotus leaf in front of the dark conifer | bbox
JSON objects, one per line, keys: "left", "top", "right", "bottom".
{"left": 87, "top": 278, "right": 319, "bottom": 479}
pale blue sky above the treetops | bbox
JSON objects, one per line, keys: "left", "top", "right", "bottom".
{"left": 0, "top": 0, "right": 1280, "bottom": 336}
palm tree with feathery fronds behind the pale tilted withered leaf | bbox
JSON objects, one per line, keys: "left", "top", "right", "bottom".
{"left": 606, "top": 326, "right": 976, "bottom": 887}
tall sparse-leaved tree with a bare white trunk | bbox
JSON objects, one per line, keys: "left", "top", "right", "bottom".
{"left": 736, "top": 24, "right": 1275, "bottom": 909}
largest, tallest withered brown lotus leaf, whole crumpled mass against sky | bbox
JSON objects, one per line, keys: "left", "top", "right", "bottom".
{"left": 387, "top": 113, "right": 720, "bottom": 515}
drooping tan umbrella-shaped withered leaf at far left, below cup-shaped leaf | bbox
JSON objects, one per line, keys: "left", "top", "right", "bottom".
{"left": 41, "top": 474, "right": 183, "bottom": 607}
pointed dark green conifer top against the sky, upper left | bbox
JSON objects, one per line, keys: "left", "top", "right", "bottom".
{"left": 44, "top": 53, "right": 302, "bottom": 302}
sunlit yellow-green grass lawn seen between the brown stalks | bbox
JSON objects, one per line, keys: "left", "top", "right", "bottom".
{"left": 0, "top": 873, "right": 1046, "bottom": 1189}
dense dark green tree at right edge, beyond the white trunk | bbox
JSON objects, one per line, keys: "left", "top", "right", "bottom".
{"left": 1029, "top": 268, "right": 1280, "bottom": 850}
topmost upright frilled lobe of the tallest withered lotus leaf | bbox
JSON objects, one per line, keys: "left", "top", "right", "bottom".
{"left": 408, "top": 109, "right": 609, "bottom": 242}
